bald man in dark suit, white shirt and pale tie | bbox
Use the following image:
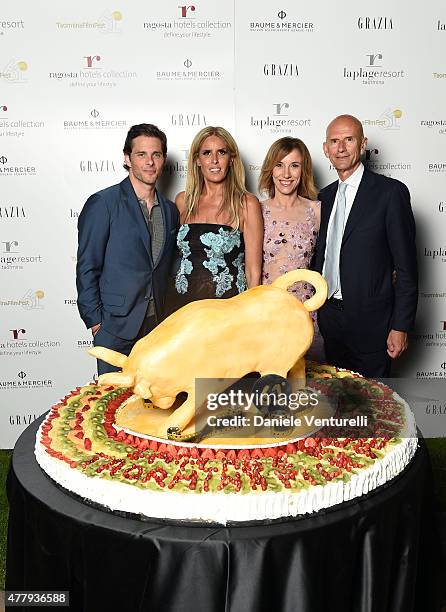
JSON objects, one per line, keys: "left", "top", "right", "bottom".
{"left": 313, "top": 115, "right": 418, "bottom": 377}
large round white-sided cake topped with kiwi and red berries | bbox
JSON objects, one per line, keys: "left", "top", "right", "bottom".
{"left": 35, "top": 365, "right": 417, "bottom": 524}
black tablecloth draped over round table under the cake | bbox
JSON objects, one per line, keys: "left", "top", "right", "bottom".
{"left": 6, "top": 422, "right": 437, "bottom": 612}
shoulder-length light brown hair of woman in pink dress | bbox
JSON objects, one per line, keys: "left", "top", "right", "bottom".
{"left": 259, "top": 136, "right": 317, "bottom": 200}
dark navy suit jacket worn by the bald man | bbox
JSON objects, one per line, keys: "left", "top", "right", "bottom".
{"left": 312, "top": 168, "right": 418, "bottom": 352}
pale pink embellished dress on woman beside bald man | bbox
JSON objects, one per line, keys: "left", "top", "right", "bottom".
{"left": 262, "top": 198, "right": 324, "bottom": 361}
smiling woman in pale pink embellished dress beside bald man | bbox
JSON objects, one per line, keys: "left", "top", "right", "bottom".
{"left": 259, "top": 136, "right": 324, "bottom": 361}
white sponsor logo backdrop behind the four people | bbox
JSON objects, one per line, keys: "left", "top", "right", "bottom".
{"left": 0, "top": 0, "right": 446, "bottom": 448}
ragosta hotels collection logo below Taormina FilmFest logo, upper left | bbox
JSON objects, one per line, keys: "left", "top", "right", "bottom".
{"left": 48, "top": 53, "right": 138, "bottom": 89}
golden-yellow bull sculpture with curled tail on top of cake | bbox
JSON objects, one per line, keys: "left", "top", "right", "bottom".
{"left": 89, "top": 269, "right": 327, "bottom": 439}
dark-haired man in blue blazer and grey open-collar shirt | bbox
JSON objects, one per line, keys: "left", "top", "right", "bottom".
{"left": 76, "top": 123, "right": 179, "bottom": 374}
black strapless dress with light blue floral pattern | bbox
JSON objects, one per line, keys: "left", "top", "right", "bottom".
{"left": 168, "top": 223, "right": 247, "bottom": 312}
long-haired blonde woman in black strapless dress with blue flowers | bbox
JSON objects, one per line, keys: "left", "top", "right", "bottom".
{"left": 168, "top": 126, "right": 263, "bottom": 312}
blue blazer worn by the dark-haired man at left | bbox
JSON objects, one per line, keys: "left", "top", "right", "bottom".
{"left": 76, "top": 178, "right": 179, "bottom": 340}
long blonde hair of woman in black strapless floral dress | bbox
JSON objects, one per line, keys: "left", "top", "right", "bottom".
{"left": 184, "top": 125, "right": 247, "bottom": 229}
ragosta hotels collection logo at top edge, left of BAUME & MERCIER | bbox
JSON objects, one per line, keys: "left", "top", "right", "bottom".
{"left": 142, "top": 2, "right": 232, "bottom": 40}
